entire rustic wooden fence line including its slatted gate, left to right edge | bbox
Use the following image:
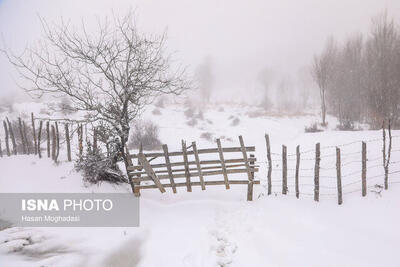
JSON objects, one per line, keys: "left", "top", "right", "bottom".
{"left": 0, "top": 113, "right": 400, "bottom": 204}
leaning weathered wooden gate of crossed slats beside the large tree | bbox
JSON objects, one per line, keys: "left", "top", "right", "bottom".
{"left": 127, "top": 136, "right": 260, "bottom": 201}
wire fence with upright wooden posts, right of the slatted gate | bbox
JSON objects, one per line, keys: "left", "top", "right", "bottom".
{"left": 256, "top": 133, "right": 400, "bottom": 204}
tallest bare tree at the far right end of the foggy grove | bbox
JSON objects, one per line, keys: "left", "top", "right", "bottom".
{"left": 365, "top": 12, "right": 400, "bottom": 125}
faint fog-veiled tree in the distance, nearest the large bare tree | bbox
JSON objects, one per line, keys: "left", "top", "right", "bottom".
{"left": 195, "top": 56, "right": 214, "bottom": 102}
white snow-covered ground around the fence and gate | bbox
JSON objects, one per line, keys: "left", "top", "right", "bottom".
{"left": 0, "top": 101, "right": 400, "bottom": 267}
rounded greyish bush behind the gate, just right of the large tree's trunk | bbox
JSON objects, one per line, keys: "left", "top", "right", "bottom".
{"left": 128, "top": 121, "right": 161, "bottom": 150}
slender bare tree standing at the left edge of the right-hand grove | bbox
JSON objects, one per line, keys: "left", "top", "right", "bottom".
{"left": 311, "top": 37, "right": 337, "bottom": 125}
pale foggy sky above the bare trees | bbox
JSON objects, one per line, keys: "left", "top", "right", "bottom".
{"left": 0, "top": 0, "right": 400, "bottom": 102}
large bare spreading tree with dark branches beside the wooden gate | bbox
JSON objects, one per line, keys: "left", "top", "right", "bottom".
{"left": 2, "top": 12, "right": 190, "bottom": 168}
